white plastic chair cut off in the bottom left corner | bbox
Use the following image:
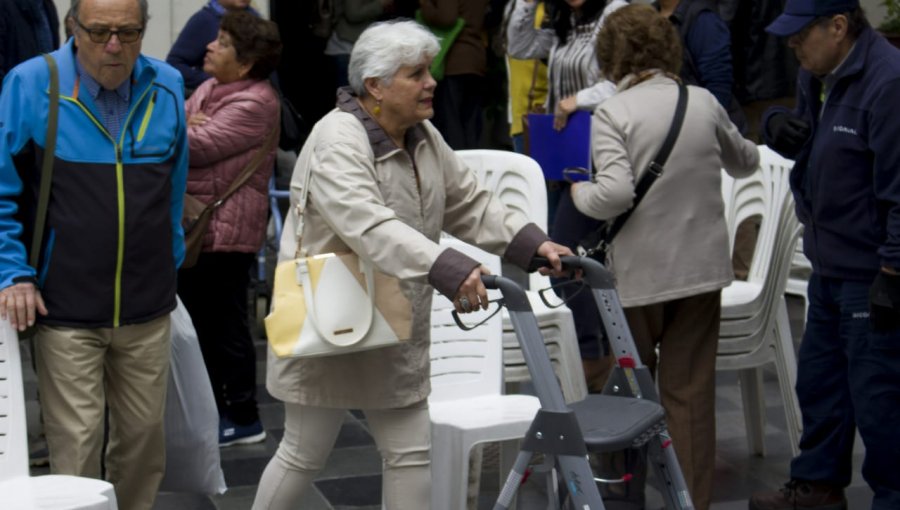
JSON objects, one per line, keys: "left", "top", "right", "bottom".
{"left": 0, "top": 320, "right": 118, "bottom": 510}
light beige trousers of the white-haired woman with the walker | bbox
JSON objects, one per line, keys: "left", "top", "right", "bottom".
{"left": 253, "top": 400, "right": 431, "bottom": 510}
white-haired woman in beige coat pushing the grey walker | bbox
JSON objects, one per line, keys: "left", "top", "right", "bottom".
{"left": 253, "top": 17, "right": 570, "bottom": 509}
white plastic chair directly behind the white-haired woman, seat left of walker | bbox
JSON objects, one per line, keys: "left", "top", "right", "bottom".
{"left": 428, "top": 238, "right": 540, "bottom": 510}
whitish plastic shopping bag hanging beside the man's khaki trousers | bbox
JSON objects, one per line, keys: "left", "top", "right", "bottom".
{"left": 160, "top": 299, "right": 226, "bottom": 495}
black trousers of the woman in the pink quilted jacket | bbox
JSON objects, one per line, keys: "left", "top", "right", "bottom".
{"left": 178, "top": 252, "right": 259, "bottom": 425}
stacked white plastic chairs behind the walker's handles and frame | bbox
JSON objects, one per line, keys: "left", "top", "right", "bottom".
{"left": 456, "top": 149, "right": 587, "bottom": 402}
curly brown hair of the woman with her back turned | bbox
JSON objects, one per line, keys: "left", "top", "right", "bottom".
{"left": 597, "top": 4, "right": 681, "bottom": 82}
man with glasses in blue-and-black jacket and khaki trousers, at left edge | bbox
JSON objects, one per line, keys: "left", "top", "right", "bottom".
{"left": 0, "top": 0, "right": 188, "bottom": 510}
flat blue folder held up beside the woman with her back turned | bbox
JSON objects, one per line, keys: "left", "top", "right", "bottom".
{"left": 528, "top": 111, "right": 591, "bottom": 181}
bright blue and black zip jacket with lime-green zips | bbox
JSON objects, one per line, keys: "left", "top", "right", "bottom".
{"left": 0, "top": 39, "right": 188, "bottom": 328}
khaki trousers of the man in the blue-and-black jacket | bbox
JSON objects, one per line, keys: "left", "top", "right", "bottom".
{"left": 34, "top": 315, "right": 170, "bottom": 510}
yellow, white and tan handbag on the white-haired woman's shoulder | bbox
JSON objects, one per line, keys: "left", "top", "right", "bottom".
{"left": 265, "top": 164, "right": 412, "bottom": 358}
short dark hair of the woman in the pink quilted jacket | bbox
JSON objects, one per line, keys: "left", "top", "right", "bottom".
{"left": 219, "top": 11, "right": 281, "bottom": 80}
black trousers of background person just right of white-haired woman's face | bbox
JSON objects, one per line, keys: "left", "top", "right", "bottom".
{"left": 434, "top": 74, "right": 484, "bottom": 150}
